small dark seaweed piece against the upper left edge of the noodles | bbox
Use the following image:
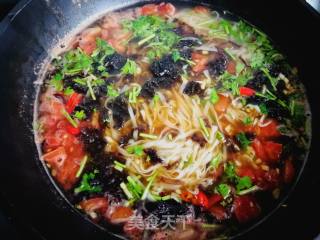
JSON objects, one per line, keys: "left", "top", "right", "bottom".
{"left": 108, "top": 95, "right": 130, "bottom": 128}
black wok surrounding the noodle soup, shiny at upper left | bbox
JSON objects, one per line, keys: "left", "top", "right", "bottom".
{"left": 0, "top": 0, "right": 320, "bottom": 240}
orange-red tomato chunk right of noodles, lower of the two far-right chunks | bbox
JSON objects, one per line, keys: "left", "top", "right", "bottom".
{"left": 252, "top": 138, "right": 282, "bottom": 163}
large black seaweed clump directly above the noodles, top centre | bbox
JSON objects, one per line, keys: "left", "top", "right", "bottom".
{"left": 150, "top": 55, "right": 181, "bottom": 79}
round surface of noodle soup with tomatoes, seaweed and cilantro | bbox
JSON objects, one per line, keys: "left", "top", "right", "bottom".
{"left": 36, "top": 3, "right": 309, "bottom": 240}
